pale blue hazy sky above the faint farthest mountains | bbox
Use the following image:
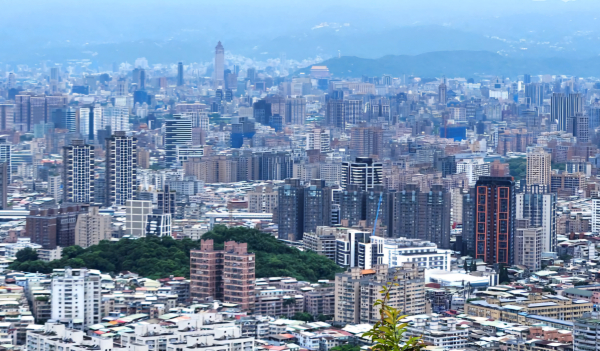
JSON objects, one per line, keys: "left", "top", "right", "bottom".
{"left": 0, "top": 0, "right": 600, "bottom": 42}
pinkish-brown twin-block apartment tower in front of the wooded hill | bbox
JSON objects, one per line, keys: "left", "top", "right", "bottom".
{"left": 190, "top": 239, "right": 255, "bottom": 311}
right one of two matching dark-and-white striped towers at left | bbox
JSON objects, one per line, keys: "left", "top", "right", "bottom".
{"left": 104, "top": 131, "right": 137, "bottom": 207}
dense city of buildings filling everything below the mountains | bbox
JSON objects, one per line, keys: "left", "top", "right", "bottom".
{"left": 0, "top": 2, "right": 600, "bottom": 351}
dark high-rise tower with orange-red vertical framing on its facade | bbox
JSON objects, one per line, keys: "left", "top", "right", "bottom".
{"left": 474, "top": 177, "right": 516, "bottom": 265}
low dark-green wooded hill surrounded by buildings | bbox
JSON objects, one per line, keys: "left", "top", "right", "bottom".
{"left": 10, "top": 226, "right": 342, "bottom": 281}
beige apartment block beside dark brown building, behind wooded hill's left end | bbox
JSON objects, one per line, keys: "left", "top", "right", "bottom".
{"left": 75, "top": 206, "right": 112, "bottom": 249}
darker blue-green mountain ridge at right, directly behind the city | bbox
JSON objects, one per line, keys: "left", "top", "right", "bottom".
{"left": 295, "top": 51, "right": 600, "bottom": 78}
